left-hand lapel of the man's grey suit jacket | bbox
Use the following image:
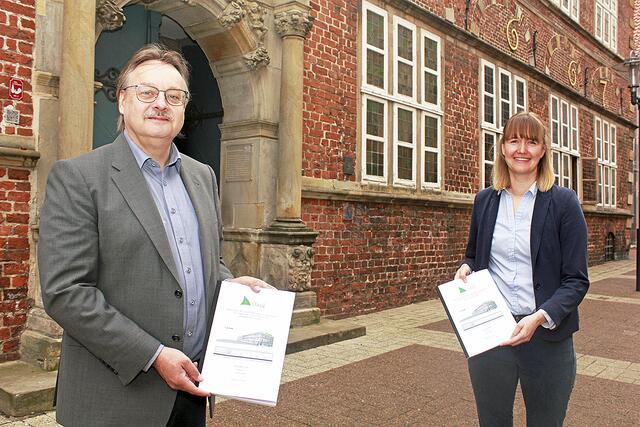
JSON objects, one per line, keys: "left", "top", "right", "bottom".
{"left": 111, "top": 138, "right": 182, "bottom": 286}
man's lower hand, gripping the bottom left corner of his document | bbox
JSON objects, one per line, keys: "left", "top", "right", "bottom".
{"left": 153, "top": 347, "right": 209, "bottom": 397}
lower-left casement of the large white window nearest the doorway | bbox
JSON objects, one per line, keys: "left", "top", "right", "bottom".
{"left": 362, "top": 95, "right": 388, "bottom": 183}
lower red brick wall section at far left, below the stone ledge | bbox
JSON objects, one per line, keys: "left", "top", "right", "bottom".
{"left": 0, "top": 168, "right": 32, "bottom": 361}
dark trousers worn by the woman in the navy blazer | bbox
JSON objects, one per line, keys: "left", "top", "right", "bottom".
{"left": 468, "top": 335, "right": 576, "bottom": 427}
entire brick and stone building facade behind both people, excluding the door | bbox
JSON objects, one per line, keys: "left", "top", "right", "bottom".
{"left": 0, "top": 0, "right": 637, "bottom": 369}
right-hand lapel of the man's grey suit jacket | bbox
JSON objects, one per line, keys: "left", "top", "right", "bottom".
{"left": 180, "top": 165, "right": 215, "bottom": 289}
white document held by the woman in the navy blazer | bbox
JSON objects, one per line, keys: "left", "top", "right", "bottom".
{"left": 438, "top": 270, "right": 516, "bottom": 357}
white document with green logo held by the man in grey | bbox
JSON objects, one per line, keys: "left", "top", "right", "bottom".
{"left": 199, "top": 281, "right": 295, "bottom": 406}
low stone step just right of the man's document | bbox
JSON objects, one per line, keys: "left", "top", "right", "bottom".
{"left": 287, "top": 319, "right": 367, "bottom": 354}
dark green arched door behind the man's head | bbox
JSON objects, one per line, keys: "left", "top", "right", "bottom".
{"left": 93, "top": 5, "right": 223, "bottom": 176}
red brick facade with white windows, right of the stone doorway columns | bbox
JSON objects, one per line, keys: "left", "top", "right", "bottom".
{"left": 302, "top": 0, "right": 635, "bottom": 317}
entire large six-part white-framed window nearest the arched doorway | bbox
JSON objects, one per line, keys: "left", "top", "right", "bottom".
{"left": 360, "top": 2, "right": 443, "bottom": 189}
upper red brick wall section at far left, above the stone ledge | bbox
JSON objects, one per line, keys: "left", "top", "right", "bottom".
{"left": 0, "top": 0, "right": 36, "bottom": 136}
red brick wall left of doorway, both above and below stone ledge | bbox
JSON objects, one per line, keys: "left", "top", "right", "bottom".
{"left": 0, "top": 0, "right": 36, "bottom": 362}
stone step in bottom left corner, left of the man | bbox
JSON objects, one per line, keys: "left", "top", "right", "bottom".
{"left": 0, "top": 361, "right": 58, "bottom": 417}
